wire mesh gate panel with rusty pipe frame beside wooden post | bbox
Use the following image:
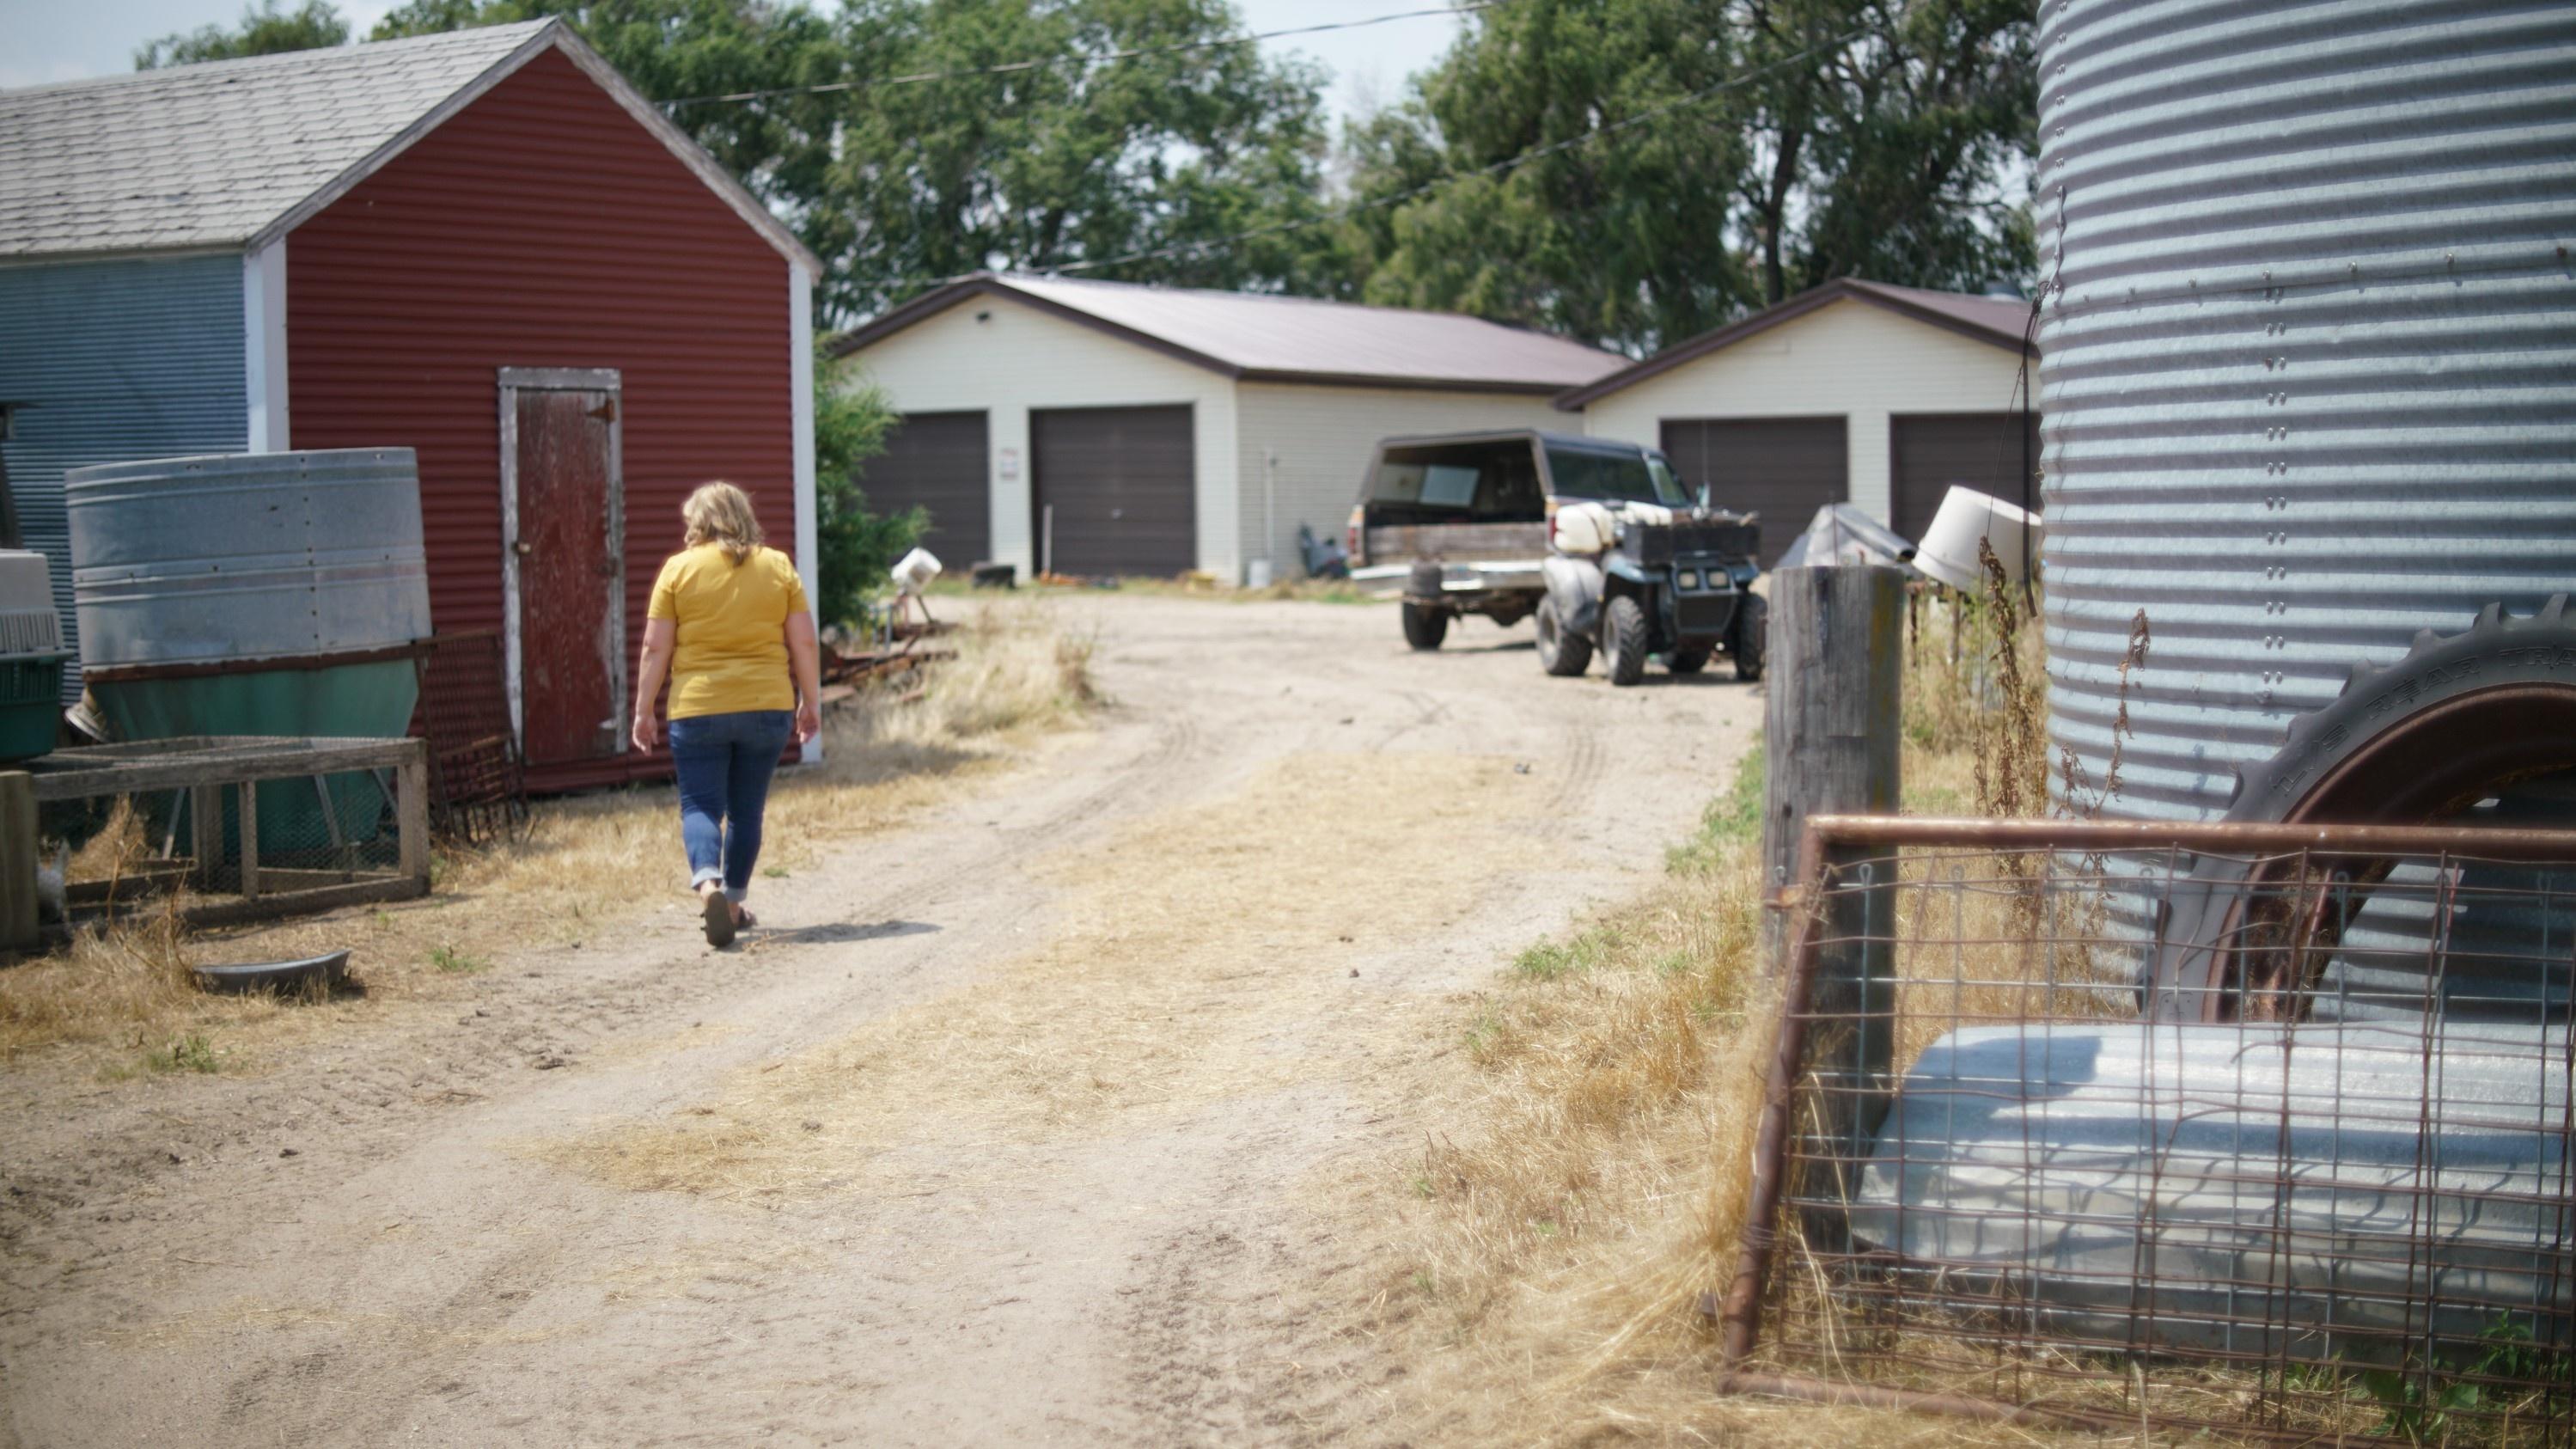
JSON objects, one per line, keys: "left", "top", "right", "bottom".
{"left": 1729, "top": 820, "right": 2576, "bottom": 1444}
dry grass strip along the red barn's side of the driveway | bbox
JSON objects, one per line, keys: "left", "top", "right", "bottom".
{"left": 0, "top": 598, "right": 1092, "bottom": 1070}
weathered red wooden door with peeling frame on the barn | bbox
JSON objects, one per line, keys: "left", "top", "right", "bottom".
{"left": 500, "top": 369, "right": 626, "bottom": 766}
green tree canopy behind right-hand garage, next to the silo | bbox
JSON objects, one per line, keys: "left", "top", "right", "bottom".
{"left": 1352, "top": 0, "right": 2035, "bottom": 351}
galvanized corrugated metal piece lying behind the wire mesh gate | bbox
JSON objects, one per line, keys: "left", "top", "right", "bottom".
{"left": 1850, "top": 1021, "right": 2576, "bottom": 1361}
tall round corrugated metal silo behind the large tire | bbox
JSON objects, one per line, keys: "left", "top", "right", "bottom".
{"left": 2037, "top": 0, "right": 2576, "bottom": 835}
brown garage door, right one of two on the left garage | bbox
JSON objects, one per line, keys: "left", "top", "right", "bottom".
{"left": 1028, "top": 405, "right": 1198, "bottom": 578}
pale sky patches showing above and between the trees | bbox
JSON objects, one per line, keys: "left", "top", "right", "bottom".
{"left": 0, "top": 0, "right": 1461, "bottom": 126}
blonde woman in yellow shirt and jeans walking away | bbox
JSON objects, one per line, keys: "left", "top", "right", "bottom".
{"left": 634, "top": 482, "right": 821, "bottom": 946}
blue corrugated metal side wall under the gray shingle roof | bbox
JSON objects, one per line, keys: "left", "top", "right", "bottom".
{"left": 0, "top": 253, "right": 250, "bottom": 699}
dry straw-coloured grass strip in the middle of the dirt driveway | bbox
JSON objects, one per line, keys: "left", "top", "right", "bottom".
{"left": 546, "top": 753, "right": 1543, "bottom": 1199}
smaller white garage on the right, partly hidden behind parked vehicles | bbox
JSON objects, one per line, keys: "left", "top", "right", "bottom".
{"left": 1556, "top": 278, "right": 2040, "bottom": 565}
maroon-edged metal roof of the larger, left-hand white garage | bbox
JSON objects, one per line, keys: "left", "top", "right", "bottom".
{"left": 832, "top": 273, "right": 1628, "bottom": 394}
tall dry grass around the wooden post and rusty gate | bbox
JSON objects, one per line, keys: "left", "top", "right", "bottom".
{"left": 1370, "top": 583, "right": 2133, "bottom": 1446}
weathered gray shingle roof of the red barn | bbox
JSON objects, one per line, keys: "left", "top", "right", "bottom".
{"left": 0, "top": 21, "right": 552, "bottom": 258}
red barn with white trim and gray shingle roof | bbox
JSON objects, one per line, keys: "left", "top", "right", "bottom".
{"left": 0, "top": 21, "right": 819, "bottom": 789}
